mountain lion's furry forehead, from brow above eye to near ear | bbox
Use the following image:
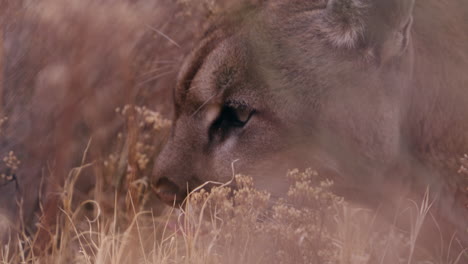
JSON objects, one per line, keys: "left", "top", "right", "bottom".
{"left": 174, "top": 2, "right": 348, "bottom": 116}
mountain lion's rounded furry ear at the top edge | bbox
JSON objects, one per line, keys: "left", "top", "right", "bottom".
{"left": 320, "top": 0, "right": 415, "bottom": 63}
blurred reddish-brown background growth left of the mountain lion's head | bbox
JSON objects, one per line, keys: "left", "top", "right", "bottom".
{"left": 0, "top": 0, "right": 210, "bottom": 245}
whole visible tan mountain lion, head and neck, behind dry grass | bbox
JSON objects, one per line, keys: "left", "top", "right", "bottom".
{"left": 155, "top": 0, "right": 468, "bottom": 258}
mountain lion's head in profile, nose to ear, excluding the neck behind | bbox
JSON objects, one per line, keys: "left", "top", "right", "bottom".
{"left": 155, "top": 0, "right": 412, "bottom": 204}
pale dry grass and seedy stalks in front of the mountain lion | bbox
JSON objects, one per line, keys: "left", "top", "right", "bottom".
{"left": 0, "top": 159, "right": 462, "bottom": 264}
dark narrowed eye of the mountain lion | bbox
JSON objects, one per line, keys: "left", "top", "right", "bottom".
{"left": 210, "top": 103, "right": 255, "bottom": 138}
